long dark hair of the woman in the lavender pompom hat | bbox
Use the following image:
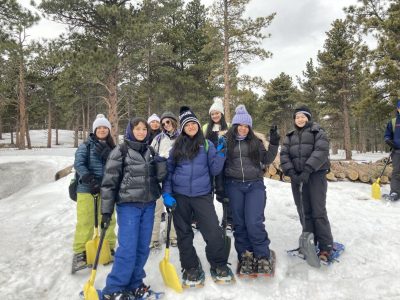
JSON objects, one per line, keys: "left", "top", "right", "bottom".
{"left": 226, "top": 124, "right": 260, "bottom": 164}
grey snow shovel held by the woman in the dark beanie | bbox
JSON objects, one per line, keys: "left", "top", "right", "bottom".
{"left": 299, "top": 183, "right": 321, "bottom": 268}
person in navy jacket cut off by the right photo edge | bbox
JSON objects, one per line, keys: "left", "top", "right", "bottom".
{"left": 385, "top": 99, "right": 400, "bottom": 201}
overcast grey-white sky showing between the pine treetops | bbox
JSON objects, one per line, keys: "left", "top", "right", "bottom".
{"left": 19, "top": 0, "right": 357, "bottom": 81}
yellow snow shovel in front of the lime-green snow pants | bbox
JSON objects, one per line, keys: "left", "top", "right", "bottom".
{"left": 86, "top": 194, "right": 112, "bottom": 265}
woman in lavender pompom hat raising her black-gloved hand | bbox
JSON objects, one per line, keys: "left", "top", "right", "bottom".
{"left": 225, "top": 105, "right": 280, "bottom": 276}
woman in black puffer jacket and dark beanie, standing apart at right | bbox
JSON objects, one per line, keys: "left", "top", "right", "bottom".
{"left": 281, "top": 106, "right": 333, "bottom": 260}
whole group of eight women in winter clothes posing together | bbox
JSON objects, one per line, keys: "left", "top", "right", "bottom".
{"left": 74, "top": 99, "right": 333, "bottom": 299}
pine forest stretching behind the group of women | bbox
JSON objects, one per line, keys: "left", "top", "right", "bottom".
{"left": 0, "top": 0, "right": 400, "bottom": 159}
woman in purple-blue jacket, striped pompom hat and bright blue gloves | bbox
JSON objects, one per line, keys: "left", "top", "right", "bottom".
{"left": 163, "top": 106, "right": 234, "bottom": 287}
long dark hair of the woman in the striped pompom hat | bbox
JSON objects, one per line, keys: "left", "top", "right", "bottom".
{"left": 172, "top": 124, "right": 205, "bottom": 163}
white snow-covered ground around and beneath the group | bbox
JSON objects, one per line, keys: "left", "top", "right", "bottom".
{"left": 0, "top": 132, "right": 400, "bottom": 300}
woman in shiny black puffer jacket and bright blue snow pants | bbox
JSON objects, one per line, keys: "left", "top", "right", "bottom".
{"left": 101, "top": 118, "right": 161, "bottom": 299}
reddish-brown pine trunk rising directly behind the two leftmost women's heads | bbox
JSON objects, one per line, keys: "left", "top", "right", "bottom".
{"left": 107, "top": 69, "right": 119, "bottom": 144}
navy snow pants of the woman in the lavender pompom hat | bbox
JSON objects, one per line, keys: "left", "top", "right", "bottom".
{"left": 225, "top": 179, "right": 270, "bottom": 259}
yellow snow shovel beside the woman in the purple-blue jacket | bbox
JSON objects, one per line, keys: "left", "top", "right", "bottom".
{"left": 160, "top": 208, "right": 183, "bottom": 293}
